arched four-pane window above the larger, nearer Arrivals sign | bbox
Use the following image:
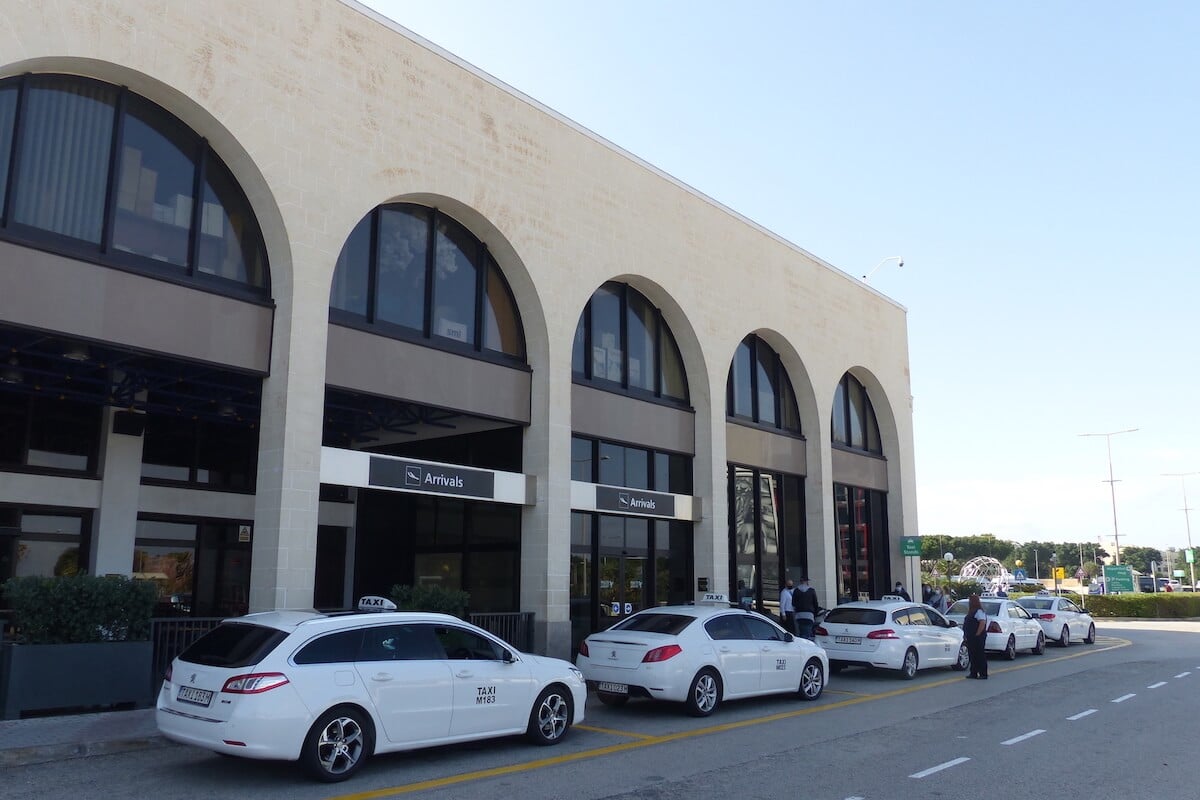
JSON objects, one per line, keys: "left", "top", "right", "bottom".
{"left": 329, "top": 203, "right": 526, "bottom": 361}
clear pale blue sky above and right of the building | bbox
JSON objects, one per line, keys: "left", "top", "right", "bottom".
{"left": 355, "top": 0, "right": 1200, "bottom": 556}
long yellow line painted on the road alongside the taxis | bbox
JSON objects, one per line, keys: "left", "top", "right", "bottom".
{"left": 329, "top": 637, "right": 1133, "bottom": 800}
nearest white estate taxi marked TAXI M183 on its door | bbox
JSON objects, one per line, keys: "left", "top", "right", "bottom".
{"left": 156, "top": 599, "right": 587, "bottom": 782}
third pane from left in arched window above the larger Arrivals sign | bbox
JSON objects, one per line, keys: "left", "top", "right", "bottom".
{"left": 433, "top": 218, "right": 479, "bottom": 347}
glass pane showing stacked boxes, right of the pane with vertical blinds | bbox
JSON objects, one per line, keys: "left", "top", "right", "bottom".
{"left": 113, "top": 97, "right": 197, "bottom": 266}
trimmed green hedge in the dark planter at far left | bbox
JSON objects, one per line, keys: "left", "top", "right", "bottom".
{"left": 4, "top": 575, "right": 158, "bottom": 644}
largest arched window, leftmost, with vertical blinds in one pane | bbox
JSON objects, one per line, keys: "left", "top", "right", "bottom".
{"left": 0, "top": 74, "right": 270, "bottom": 297}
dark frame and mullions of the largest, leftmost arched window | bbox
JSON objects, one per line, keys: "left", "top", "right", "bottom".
{"left": 0, "top": 72, "right": 271, "bottom": 305}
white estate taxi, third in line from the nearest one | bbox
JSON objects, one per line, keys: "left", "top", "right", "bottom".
{"left": 816, "top": 595, "right": 971, "bottom": 680}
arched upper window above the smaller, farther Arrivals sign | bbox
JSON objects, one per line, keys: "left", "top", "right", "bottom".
{"left": 571, "top": 282, "right": 688, "bottom": 403}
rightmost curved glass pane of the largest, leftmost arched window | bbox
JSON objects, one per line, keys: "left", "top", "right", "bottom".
{"left": 197, "top": 151, "right": 266, "bottom": 288}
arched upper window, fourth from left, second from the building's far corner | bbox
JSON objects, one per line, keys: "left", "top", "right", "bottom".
{"left": 725, "top": 333, "right": 800, "bottom": 433}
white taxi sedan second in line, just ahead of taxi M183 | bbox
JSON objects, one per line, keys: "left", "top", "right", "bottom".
{"left": 575, "top": 595, "right": 829, "bottom": 717}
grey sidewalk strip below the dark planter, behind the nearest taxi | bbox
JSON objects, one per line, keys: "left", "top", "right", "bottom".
{"left": 0, "top": 708, "right": 170, "bottom": 770}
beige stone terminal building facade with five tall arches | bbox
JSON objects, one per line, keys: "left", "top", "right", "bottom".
{"left": 0, "top": 0, "right": 917, "bottom": 656}
